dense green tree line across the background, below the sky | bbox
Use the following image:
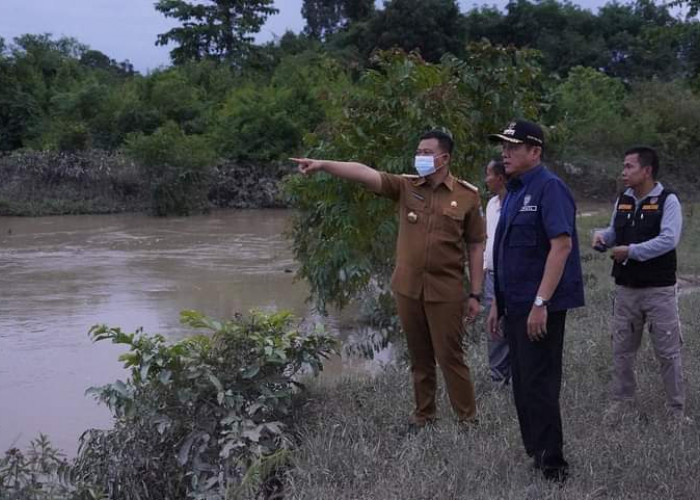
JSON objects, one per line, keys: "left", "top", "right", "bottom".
{"left": 0, "top": 0, "right": 700, "bottom": 162}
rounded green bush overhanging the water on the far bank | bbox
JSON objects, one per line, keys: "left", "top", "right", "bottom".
{"left": 126, "top": 122, "right": 214, "bottom": 215}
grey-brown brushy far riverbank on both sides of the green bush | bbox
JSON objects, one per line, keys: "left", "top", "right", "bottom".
{"left": 0, "top": 150, "right": 290, "bottom": 216}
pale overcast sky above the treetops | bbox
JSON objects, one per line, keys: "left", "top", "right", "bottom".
{"left": 0, "top": 0, "right": 607, "bottom": 72}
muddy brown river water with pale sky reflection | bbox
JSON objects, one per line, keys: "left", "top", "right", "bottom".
{"left": 0, "top": 210, "right": 388, "bottom": 454}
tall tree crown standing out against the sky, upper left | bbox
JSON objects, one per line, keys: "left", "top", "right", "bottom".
{"left": 155, "top": 0, "right": 278, "bottom": 65}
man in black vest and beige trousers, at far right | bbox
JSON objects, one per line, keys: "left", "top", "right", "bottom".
{"left": 593, "top": 146, "right": 685, "bottom": 421}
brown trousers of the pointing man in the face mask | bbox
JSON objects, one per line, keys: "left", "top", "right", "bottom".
{"left": 395, "top": 294, "right": 476, "bottom": 424}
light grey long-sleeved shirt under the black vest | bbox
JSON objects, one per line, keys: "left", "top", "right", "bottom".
{"left": 603, "top": 182, "right": 683, "bottom": 262}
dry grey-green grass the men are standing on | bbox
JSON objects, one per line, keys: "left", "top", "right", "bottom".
{"left": 285, "top": 207, "right": 700, "bottom": 500}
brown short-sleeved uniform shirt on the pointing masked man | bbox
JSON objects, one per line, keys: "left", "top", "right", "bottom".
{"left": 379, "top": 173, "right": 485, "bottom": 302}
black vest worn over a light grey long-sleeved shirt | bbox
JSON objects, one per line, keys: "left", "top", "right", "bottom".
{"left": 612, "top": 189, "right": 676, "bottom": 288}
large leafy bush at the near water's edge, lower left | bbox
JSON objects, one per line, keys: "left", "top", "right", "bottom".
{"left": 76, "top": 312, "right": 335, "bottom": 500}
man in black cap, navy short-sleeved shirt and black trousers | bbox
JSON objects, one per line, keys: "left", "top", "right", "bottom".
{"left": 487, "top": 120, "right": 584, "bottom": 481}
